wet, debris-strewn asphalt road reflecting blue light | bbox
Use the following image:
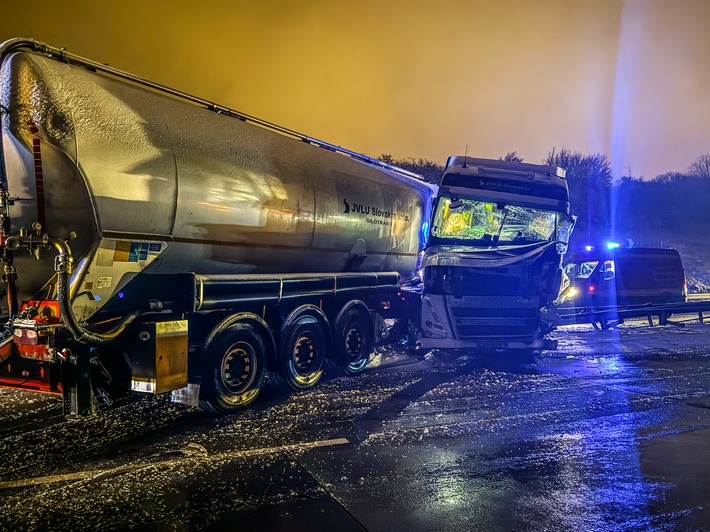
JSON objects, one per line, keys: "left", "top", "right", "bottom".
{"left": 0, "top": 321, "right": 710, "bottom": 532}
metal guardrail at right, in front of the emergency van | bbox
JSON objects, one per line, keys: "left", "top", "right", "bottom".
{"left": 557, "top": 294, "right": 710, "bottom": 329}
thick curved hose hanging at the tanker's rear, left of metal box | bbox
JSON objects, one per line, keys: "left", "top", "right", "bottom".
{"left": 50, "top": 239, "right": 140, "bottom": 344}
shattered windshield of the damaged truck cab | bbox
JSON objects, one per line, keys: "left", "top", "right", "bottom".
{"left": 432, "top": 197, "right": 573, "bottom": 245}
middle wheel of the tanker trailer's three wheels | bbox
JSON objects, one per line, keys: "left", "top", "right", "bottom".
{"left": 269, "top": 305, "right": 329, "bottom": 392}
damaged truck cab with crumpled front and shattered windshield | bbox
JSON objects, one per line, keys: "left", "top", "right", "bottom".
{"left": 420, "top": 157, "right": 574, "bottom": 350}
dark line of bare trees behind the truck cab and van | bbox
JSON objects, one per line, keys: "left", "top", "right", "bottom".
{"left": 380, "top": 148, "right": 710, "bottom": 249}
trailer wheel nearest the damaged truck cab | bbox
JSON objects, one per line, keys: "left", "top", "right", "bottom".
{"left": 328, "top": 301, "right": 375, "bottom": 375}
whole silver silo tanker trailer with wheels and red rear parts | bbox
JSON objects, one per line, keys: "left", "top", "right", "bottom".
{"left": 0, "top": 39, "right": 434, "bottom": 415}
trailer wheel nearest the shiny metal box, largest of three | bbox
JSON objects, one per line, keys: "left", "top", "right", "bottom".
{"left": 200, "top": 322, "right": 266, "bottom": 413}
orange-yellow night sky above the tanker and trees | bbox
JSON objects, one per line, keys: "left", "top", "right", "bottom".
{"left": 0, "top": 0, "right": 710, "bottom": 178}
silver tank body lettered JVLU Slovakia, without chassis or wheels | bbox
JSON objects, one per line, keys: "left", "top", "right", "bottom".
{"left": 0, "top": 43, "right": 433, "bottom": 317}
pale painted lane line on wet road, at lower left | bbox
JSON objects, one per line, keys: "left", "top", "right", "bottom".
{"left": 0, "top": 438, "right": 350, "bottom": 490}
